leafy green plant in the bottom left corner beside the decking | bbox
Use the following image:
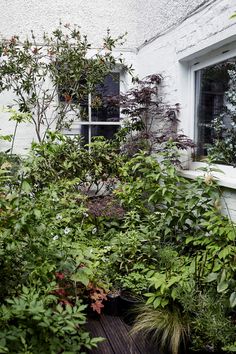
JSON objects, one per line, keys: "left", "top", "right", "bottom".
{"left": 0, "top": 287, "right": 100, "bottom": 354}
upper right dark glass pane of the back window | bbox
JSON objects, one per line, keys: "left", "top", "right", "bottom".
{"left": 92, "top": 73, "right": 120, "bottom": 122}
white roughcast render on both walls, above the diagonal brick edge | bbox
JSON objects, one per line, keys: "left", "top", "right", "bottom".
{"left": 0, "top": 0, "right": 209, "bottom": 48}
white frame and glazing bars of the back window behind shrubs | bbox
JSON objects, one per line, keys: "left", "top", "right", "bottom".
{"left": 62, "top": 69, "right": 127, "bottom": 143}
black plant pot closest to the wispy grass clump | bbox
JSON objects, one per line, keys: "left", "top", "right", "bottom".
{"left": 119, "top": 290, "right": 142, "bottom": 326}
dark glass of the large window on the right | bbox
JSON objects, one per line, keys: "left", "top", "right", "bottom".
{"left": 195, "top": 58, "right": 236, "bottom": 157}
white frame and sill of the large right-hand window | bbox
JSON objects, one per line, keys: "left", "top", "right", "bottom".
{"left": 182, "top": 42, "right": 236, "bottom": 189}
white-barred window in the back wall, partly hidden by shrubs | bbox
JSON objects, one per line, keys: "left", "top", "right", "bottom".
{"left": 59, "top": 72, "right": 121, "bottom": 144}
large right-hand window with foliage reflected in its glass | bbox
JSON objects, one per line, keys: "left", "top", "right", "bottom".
{"left": 192, "top": 50, "right": 236, "bottom": 167}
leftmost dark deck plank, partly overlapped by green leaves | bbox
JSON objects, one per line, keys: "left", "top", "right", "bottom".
{"left": 86, "top": 319, "right": 115, "bottom": 354}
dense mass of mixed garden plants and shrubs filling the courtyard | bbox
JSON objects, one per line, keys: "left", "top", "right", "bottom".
{"left": 0, "top": 23, "right": 236, "bottom": 354}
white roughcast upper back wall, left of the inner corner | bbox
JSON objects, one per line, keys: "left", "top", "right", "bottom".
{"left": 0, "top": 0, "right": 138, "bottom": 48}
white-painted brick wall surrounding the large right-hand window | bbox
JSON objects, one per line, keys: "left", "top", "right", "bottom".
{"left": 137, "top": 0, "right": 236, "bottom": 220}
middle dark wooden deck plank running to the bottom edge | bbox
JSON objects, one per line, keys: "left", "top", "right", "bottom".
{"left": 100, "top": 315, "right": 141, "bottom": 354}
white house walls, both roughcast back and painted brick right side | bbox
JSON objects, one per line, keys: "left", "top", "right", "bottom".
{"left": 0, "top": 0, "right": 236, "bottom": 218}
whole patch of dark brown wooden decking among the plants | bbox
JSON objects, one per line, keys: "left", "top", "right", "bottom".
{"left": 86, "top": 315, "right": 154, "bottom": 354}
